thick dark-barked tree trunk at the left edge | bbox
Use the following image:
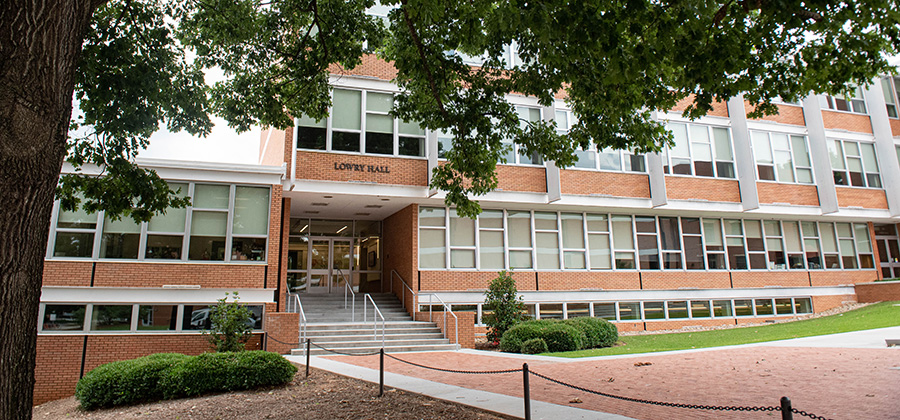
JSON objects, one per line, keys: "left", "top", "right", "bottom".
{"left": 0, "top": 0, "right": 97, "bottom": 419}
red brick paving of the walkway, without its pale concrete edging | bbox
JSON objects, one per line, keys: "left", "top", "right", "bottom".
{"left": 328, "top": 347, "right": 900, "bottom": 419}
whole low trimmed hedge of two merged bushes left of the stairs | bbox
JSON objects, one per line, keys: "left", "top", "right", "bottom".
{"left": 75, "top": 351, "right": 297, "bottom": 410}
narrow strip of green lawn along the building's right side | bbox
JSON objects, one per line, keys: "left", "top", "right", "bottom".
{"left": 545, "top": 302, "right": 900, "bottom": 357}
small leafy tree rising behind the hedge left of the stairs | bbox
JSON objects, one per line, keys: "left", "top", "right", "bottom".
{"left": 203, "top": 292, "right": 253, "bottom": 352}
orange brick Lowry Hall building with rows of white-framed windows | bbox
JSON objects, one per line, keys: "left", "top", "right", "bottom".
{"left": 35, "top": 57, "right": 900, "bottom": 403}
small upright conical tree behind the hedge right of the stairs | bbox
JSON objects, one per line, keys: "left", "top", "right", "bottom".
{"left": 484, "top": 270, "right": 525, "bottom": 342}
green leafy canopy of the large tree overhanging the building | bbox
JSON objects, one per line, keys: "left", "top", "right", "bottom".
{"left": 63, "top": 0, "right": 900, "bottom": 219}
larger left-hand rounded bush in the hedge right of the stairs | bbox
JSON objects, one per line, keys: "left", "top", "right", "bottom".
{"left": 500, "top": 320, "right": 585, "bottom": 353}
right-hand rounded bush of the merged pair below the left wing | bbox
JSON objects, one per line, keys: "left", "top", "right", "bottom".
{"left": 160, "top": 351, "right": 297, "bottom": 398}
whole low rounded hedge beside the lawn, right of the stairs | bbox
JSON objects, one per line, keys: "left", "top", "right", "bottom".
{"left": 500, "top": 317, "right": 619, "bottom": 354}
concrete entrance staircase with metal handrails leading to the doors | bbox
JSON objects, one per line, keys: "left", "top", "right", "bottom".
{"left": 291, "top": 293, "right": 459, "bottom": 356}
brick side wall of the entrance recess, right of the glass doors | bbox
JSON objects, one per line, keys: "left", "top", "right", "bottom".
{"left": 382, "top": 204, "right": 419, "bottom": 309}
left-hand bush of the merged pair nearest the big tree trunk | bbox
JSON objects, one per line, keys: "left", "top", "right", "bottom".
{"left": 75, "top": 353, "right": 189, "bottom": 410}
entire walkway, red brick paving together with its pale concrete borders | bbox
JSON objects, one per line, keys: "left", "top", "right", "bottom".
{"left": 291, "top": 327, "right": 900, "bottom": 419}
